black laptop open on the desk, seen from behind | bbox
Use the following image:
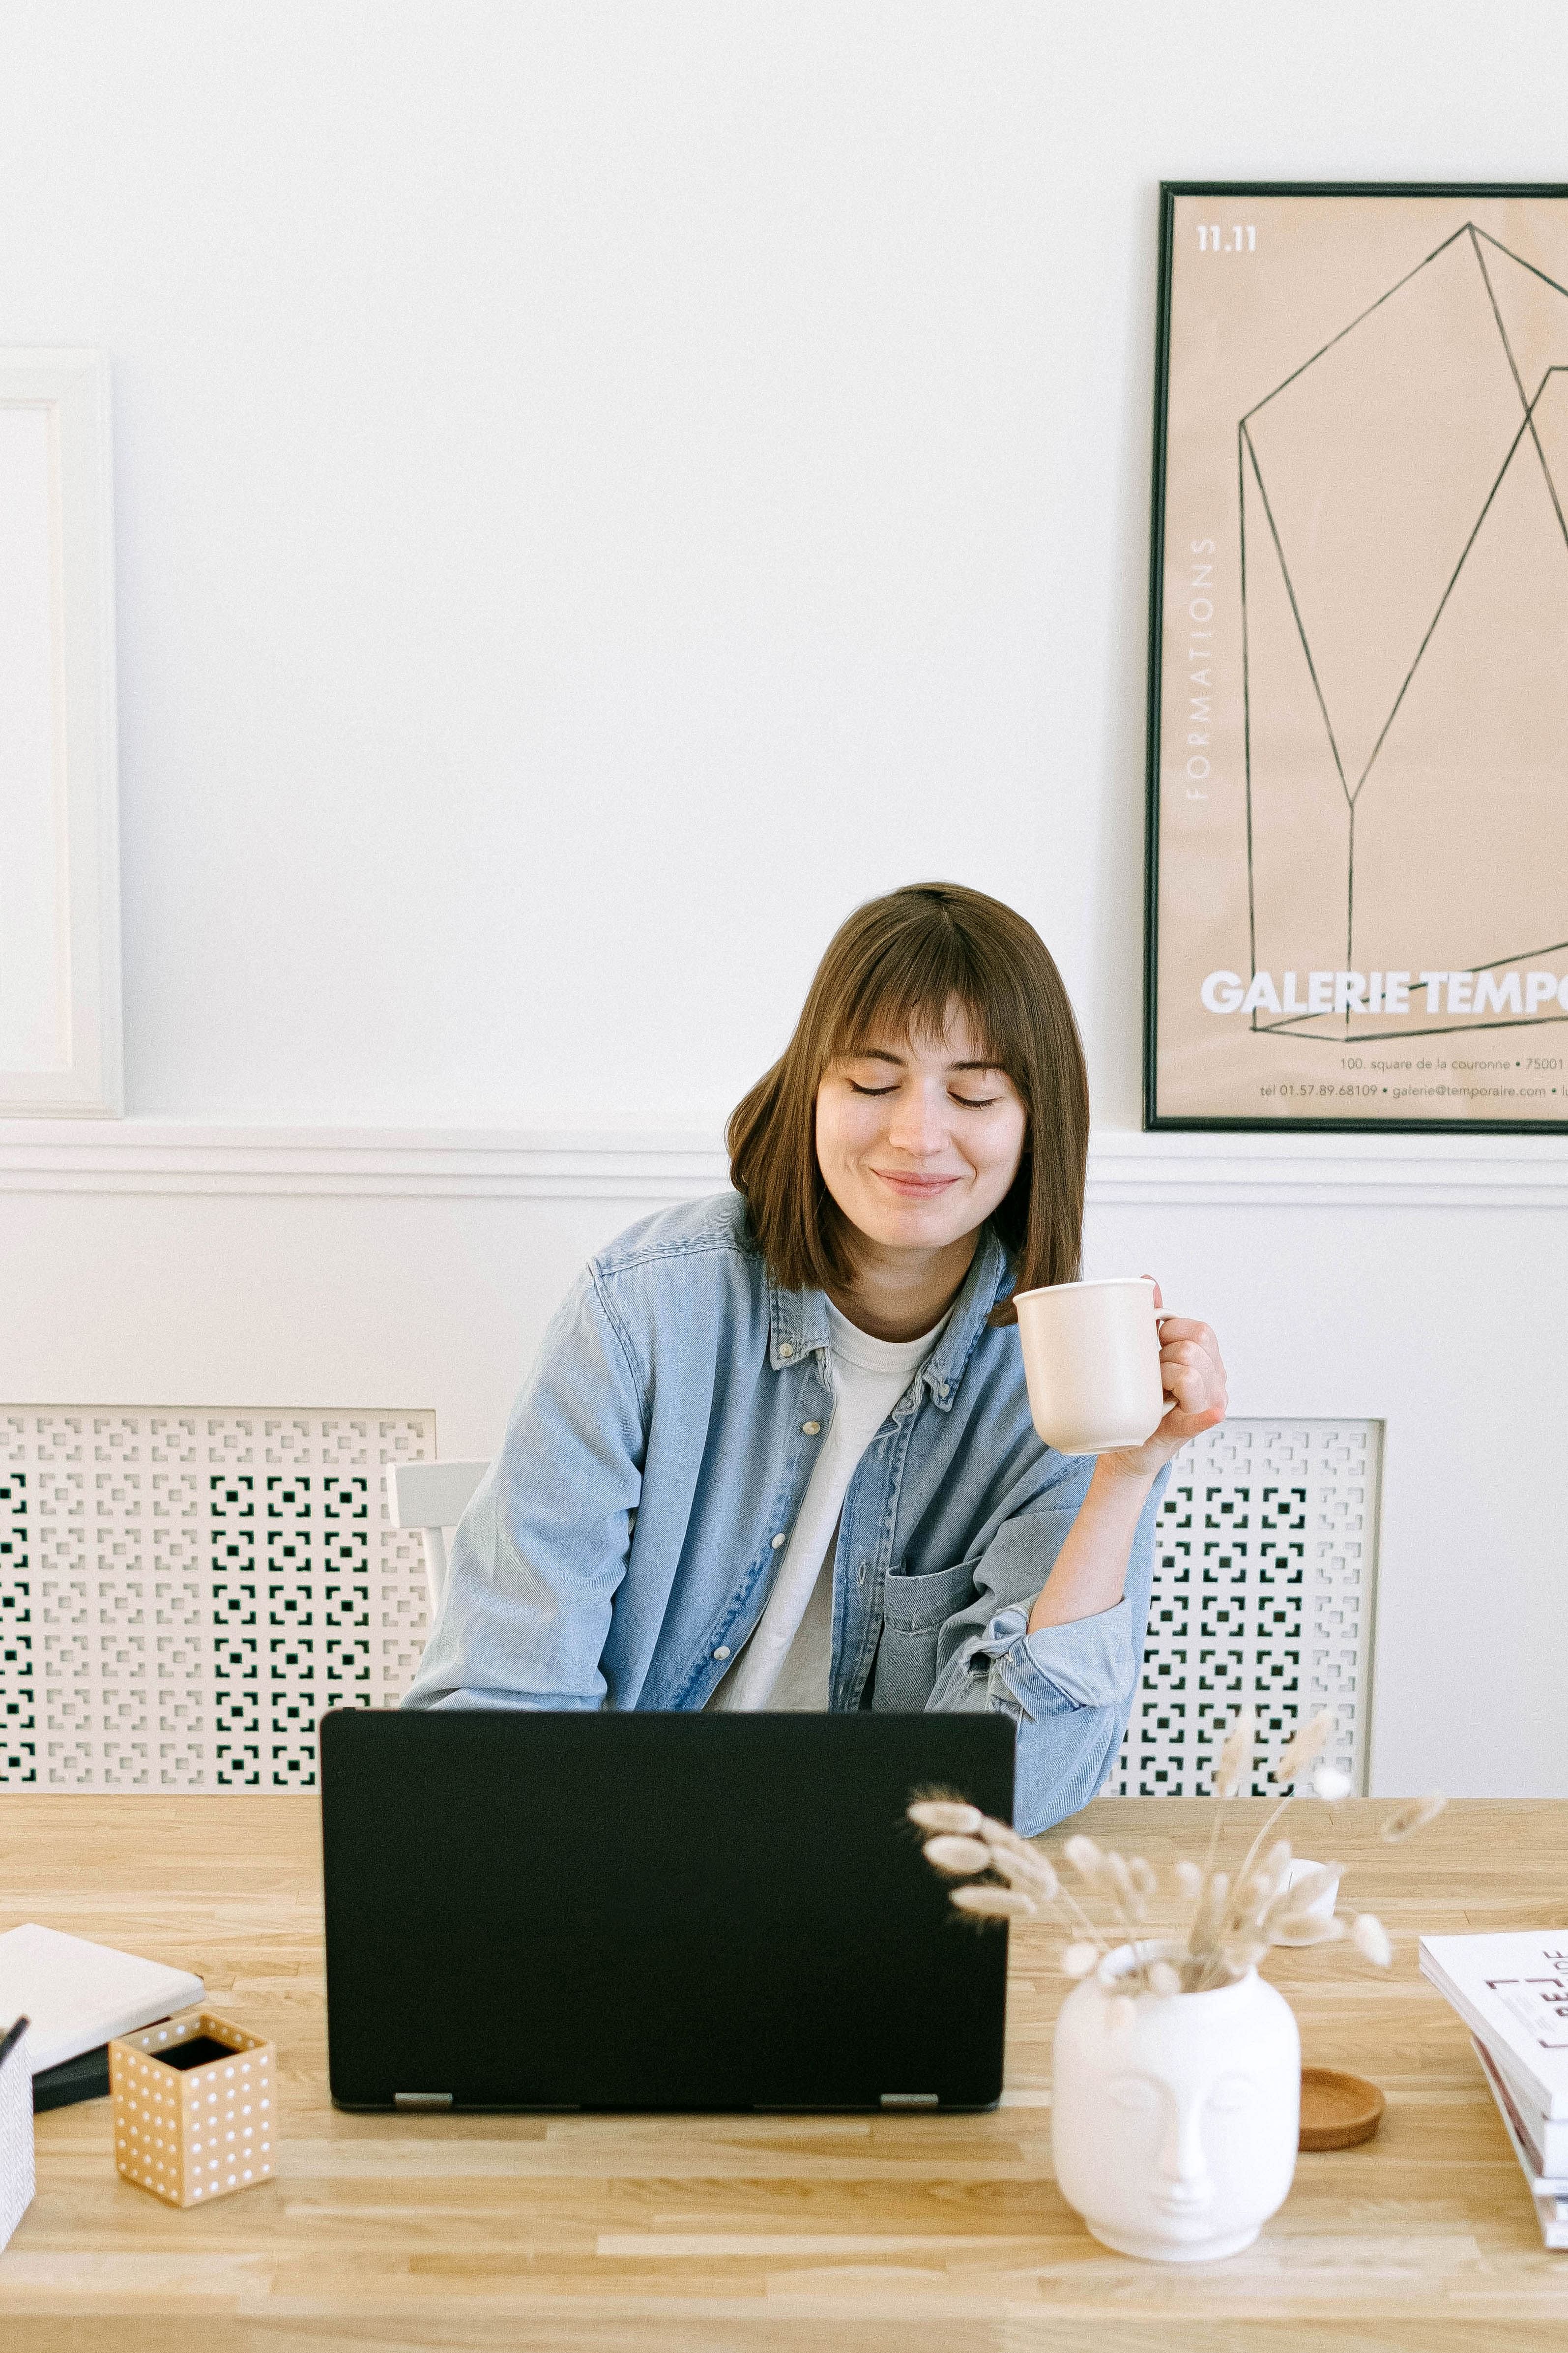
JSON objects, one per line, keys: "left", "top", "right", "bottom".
{"left": 319, "top": 1708, "right": 1013, "bottom": 2111}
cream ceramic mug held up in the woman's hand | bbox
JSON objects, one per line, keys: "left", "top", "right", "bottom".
{"left": 1016, "top": 1275, "right": 1168, "bottom": 1454}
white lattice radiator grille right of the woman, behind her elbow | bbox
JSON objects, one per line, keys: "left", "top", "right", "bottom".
{"left": 1107, "top": 1419, "right": 1382, "bottom": 1798}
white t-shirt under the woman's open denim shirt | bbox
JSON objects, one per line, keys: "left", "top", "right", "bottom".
{"left": 708, "top": 1299, "right": 952, "bottom": 1713}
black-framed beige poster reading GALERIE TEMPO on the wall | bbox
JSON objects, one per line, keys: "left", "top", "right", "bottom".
{"left": 1145, "top": 183, "right": 1568, "bottom": 1132}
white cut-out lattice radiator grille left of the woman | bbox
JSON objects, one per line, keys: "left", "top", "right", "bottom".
{"left": 0, "top": 1405, "right": 435, "bottom": 1791}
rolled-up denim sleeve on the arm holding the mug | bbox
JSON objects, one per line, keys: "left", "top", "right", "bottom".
{"left": 929, "top": 1468, "right": 1171, "bottom": 1838}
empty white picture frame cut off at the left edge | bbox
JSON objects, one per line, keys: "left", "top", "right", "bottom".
{"left": 0, "top": 351, "right": 122, "bottom": 1118}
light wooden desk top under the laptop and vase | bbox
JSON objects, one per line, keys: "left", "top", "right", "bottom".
{"left": 0, "top": 1795, "right": 1568, "bottom": 2353}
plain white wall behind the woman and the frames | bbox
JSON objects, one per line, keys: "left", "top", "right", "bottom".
{"left": 0, "top": 0, "right": 1568, "bottom": 1793}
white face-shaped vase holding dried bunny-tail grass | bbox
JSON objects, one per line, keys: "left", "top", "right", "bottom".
{"left": 1051, "top": 1972, "right": 1300, "bottom": 2264}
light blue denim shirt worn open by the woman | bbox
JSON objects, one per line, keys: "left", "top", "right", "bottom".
{"left": 405, "top": 1193, "right": 1163, "bottom": 1833}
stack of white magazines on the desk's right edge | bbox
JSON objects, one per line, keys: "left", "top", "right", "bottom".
{"left": 1420, "top": 1930, "right": 1568, "bottom": 2247}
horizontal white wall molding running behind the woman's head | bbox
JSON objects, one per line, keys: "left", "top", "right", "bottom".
{"left": 0, "top": 1118, "right": 1568, "bottom": 1209}
